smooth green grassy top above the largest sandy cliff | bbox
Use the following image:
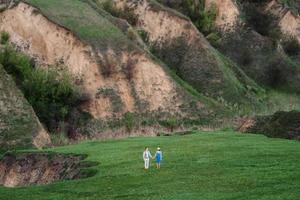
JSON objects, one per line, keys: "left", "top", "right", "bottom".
{"left": 23, "top": 0, "right": 128, "bottom": 52}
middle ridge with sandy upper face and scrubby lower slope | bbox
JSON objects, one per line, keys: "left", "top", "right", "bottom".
{"left": 103, "top": 0, "right": 259, "bottom": 104}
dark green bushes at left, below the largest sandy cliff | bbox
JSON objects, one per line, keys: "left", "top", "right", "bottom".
{"left": 0, "top": 46, "right": 79, "bottom": 130}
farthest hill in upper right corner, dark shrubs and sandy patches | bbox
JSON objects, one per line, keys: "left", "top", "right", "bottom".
{"left": 162, "top": 0, "right": 300, "bottom": 93}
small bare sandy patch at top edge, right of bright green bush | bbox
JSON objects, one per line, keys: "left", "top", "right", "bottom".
{"left": 205, "top": 0, "right": 240, "bottom": 31}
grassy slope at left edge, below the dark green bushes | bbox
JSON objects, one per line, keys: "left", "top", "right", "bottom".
{"left": 0, "top": 65, "right": 47, "bottom": 152}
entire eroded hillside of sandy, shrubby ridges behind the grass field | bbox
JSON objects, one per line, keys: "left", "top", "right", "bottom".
{"left": 0, "top": 0, "right": 300, "bottom": 146}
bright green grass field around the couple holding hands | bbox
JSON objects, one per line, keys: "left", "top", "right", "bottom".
{"left": 0, "top": 132, "right": 300, "bottom": 200}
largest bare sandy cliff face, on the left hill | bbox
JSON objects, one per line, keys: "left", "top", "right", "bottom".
{"left": 0, "top": 3, "right": 185, "bottom": 118}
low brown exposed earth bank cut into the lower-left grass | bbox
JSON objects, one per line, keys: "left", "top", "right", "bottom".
{"left": 0, "top": 153, "right": 96, "bottom": 187}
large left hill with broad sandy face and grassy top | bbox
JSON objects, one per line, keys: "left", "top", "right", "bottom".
{"left": 0, "top": 0, "right": 225, "bottom": 143}
